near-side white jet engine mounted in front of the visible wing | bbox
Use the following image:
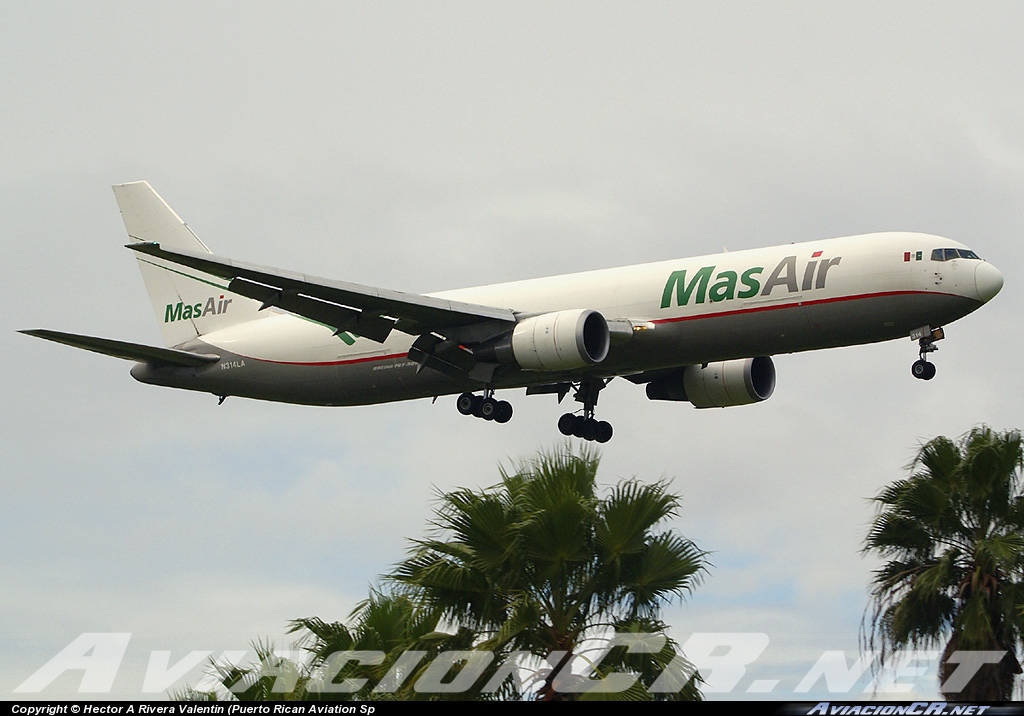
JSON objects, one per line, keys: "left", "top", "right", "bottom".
{"left": 496, "top": 308, "right": 611, "bottom": 371}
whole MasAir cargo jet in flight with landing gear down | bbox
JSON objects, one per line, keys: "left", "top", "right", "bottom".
{"left": 22, "top": 181, "right": 1002, "bottom": 443}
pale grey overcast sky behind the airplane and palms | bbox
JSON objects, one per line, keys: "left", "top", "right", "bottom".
{"left": 0, "top": 1, "right": 1024, "bottom": 699}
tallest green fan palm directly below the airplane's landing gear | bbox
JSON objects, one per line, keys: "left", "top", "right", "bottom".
{"left": 390, "top": 448, "right": 707, "bottom": 701}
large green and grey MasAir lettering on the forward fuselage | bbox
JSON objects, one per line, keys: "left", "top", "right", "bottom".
{"left": 662, "top": 251, "right": 843, "bottom": 308}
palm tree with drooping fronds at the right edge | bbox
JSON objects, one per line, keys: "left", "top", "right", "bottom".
{"left": 864, "top": 427, "right": 1024, "bottom": 701}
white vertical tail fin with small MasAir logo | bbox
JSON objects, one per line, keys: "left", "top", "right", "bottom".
{"left": 114, "top": 181, "right": 260, "bottom": 346}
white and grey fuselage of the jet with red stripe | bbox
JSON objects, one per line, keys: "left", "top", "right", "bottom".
{"left": 132, "top": 233, "right": 1001, "bottom": 405}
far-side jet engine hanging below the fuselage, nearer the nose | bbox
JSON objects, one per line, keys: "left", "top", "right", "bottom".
{"left": 647, "top": 355, "right": 775, "bottom": 408}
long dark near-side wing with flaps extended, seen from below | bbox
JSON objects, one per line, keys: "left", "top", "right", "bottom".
{"left": 127, "top": 242, "right": 516, "bottom": 343}
